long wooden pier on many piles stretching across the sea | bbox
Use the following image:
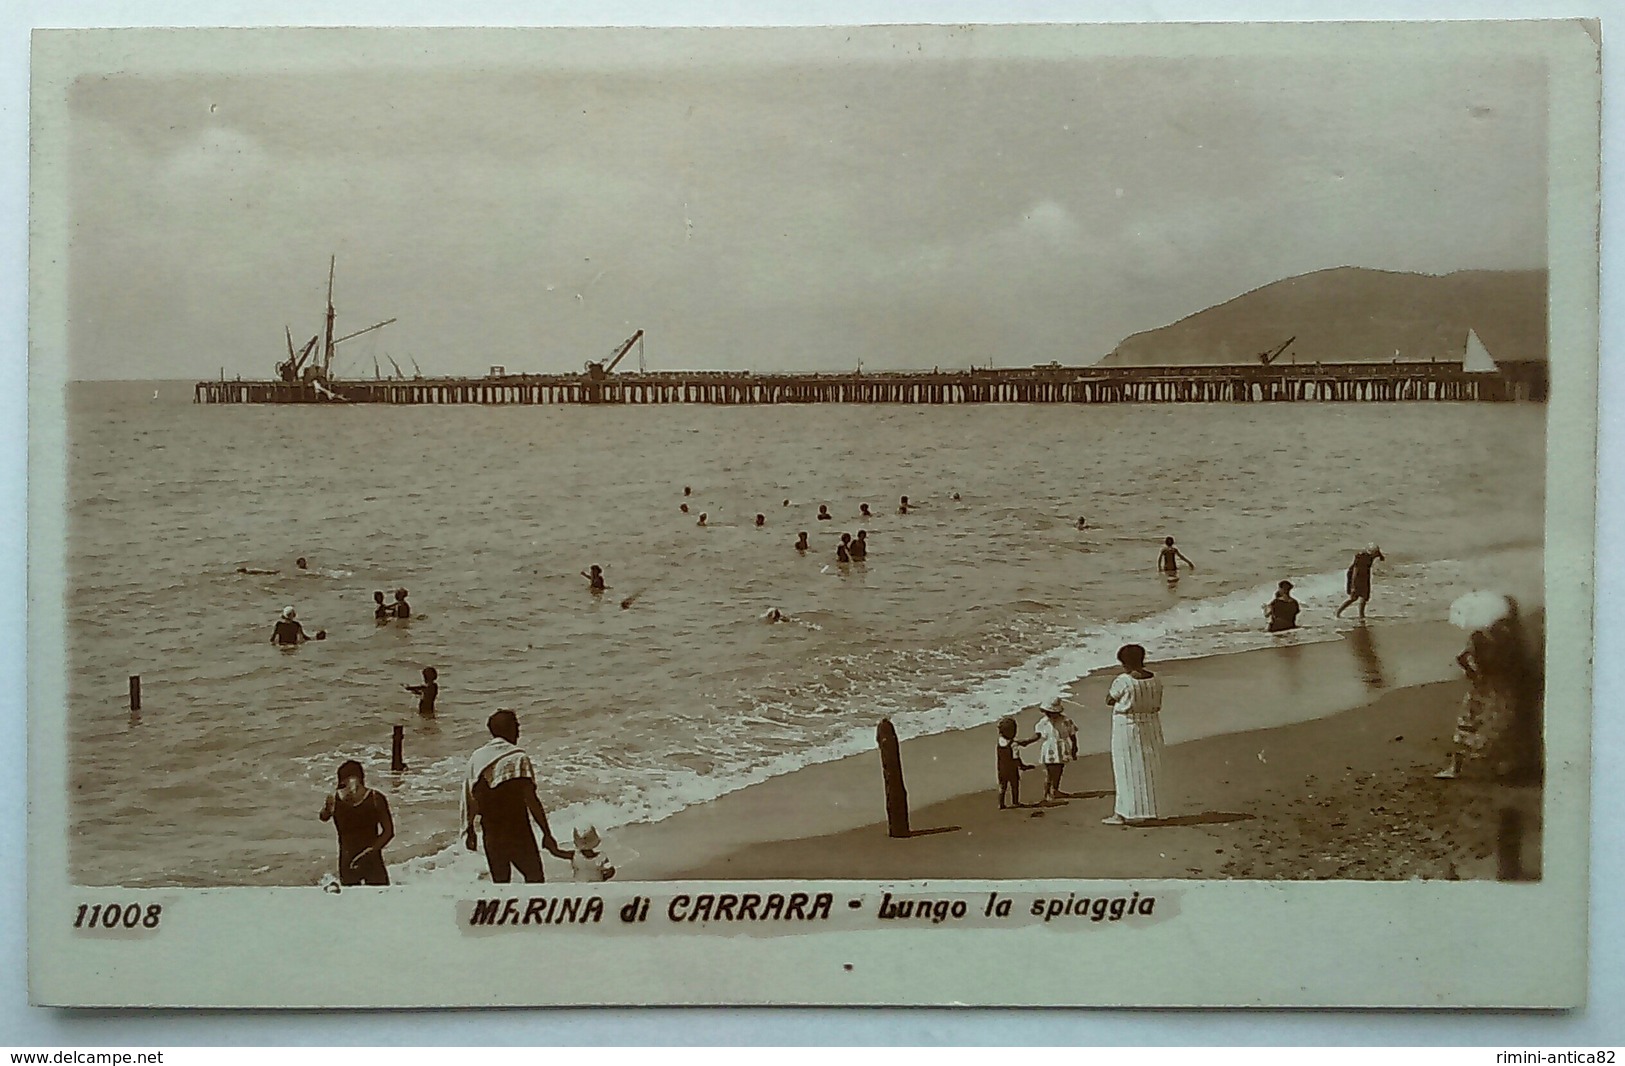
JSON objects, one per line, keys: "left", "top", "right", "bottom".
{"left": 193, "top": 361, "right": 1549, "bottom": 405}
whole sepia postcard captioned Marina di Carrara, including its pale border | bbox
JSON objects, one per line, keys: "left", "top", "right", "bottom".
{"left": 28, "top": 21, "right": 1601, "bottom": 1008}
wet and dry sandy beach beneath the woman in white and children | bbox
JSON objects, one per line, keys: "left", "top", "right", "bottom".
{"left": 614, "top": 621, "right": 1541, "bottom": 881}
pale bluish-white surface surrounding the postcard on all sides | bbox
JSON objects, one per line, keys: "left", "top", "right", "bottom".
{"left": 0, "top": 3, "right": 1625, "bottom": 1047}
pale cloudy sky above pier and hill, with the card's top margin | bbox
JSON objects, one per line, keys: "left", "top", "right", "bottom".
{"left": 54, "top": 28, "right": 1547, "bottom": 379}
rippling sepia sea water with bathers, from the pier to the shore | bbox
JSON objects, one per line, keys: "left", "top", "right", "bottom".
{"left": 57, "top": 382, "right": 1545, "bottom": 886}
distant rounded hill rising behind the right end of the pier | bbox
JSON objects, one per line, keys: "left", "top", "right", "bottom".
{"left": 1100, "top": 267, "right": 1547, "bottom": 366}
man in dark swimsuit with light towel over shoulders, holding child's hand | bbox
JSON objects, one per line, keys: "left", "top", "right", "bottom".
{"left": 463, "top": 710, "right": 572, "bottom": 884}
